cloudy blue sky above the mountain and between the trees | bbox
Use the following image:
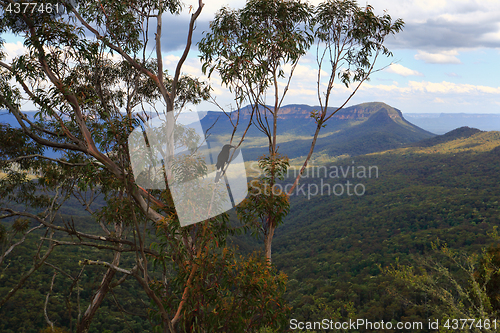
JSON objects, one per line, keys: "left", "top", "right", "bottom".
{"left": 5, "top": 0, "right": 500, "bottom": 113}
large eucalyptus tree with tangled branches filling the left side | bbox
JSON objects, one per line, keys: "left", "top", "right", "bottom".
{"left": 0, "top": 0, "right": 287, "bottom": 332}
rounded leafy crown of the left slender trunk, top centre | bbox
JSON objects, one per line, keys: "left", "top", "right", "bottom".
{"left": 198, "top": 0, "right": 313, "bottom": 96}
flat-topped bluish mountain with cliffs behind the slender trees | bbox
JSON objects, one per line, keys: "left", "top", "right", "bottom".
{"left": 201, "top": 102, "right": 434, "bottom": 160}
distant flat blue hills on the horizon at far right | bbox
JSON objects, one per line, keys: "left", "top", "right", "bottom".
{"left": 404, "top": 113, "right": 500, "bottom": 134}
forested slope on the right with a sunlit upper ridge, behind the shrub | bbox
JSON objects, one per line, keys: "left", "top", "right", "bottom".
{"left": 259, "top": 129, "right": 500, "bottom": 321}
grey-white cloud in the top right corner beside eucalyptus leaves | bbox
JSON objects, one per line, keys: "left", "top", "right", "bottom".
{"left": 372, "top": 0, "right": 500, "bottom": 53}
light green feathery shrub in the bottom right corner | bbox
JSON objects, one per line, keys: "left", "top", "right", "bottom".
{"left": 383, "top": 240, "right": 499, "bottom": 326}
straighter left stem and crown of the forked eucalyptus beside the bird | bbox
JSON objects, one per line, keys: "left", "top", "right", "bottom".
{"left": 199, "top": 0, "right": 314, "bottom": 259}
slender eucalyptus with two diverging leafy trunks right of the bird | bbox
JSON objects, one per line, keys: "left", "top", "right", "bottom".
{"left": 199, "top": 0, "right": 403, "bottom": 261}
